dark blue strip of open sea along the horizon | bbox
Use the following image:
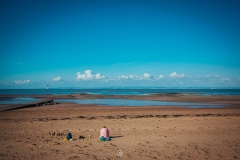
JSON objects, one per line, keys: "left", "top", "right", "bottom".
{"left": 0, "top": 89, "right": 240, "bottom": 96}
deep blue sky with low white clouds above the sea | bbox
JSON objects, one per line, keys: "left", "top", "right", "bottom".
{"left": 0, "top": 0, "right": 240, "bottom": 88}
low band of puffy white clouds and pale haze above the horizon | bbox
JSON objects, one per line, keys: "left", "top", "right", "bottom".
{"left": 0, "top": 70, "right": 240, "bottom": 88}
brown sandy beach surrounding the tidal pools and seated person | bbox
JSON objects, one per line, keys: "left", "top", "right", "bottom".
{"left": 0, "top": 95, "right": 240, "bottom": 160}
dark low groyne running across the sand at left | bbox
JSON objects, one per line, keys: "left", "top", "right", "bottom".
{"left": 0, "top": 100, "right": 54, "bottom": 112}
